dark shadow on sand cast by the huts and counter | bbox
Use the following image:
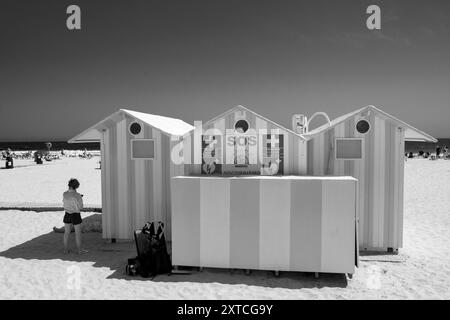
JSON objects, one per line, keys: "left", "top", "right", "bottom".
{"left": 0, "top": 214, "right": 348, "bottom": 289}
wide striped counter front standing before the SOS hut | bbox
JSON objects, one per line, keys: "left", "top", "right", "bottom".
{"left": 171, "top": 176, "right": 358, "bottom": 273}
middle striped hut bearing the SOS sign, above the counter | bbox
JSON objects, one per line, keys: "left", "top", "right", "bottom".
{"left": 184, "top": 105, "right": 306, "bottom": 176}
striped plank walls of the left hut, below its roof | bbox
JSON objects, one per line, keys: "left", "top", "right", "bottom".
{"left": 101, "top": 115, "right": 184, "bottom": 239}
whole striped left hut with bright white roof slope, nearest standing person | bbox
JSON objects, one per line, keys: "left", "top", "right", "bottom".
{"left": 69, "top": 109, "right": 194, "bottom": 239}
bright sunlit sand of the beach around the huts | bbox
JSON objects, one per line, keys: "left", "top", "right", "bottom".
{"left": 0, "top": 157, "right": 450, "bottom": 299}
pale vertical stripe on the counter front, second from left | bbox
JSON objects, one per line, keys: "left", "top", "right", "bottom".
{"left": 200, "top": 179, "right": 230, "bottom": 268}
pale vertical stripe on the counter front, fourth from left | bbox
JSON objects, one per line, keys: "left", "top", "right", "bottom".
{"left": 259, "top": 179, "right": 291, "bottom": 270}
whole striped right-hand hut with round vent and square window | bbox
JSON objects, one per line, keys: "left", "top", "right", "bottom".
{"left": 303, "top": 106, "right": 437, "bottom": 251}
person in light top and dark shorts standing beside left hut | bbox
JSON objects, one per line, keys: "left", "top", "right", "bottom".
{"left": 63, "top": 178, "right": 87, "bottom": 253}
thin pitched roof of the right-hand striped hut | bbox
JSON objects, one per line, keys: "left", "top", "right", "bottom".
{"left": 303, "top": 105, "right": 437, "bottom": 142}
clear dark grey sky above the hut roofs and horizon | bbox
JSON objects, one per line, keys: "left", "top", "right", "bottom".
{"left": 0, "top": 0, "right": 450, "bottom": 141}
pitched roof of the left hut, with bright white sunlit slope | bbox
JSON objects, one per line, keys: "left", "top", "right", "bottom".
{"left": 69, "top": 109, "right": 194, "bottom": 143}
